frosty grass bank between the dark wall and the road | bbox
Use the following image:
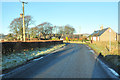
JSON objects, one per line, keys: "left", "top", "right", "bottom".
{"left": 2, "top": 44, "right": 65, "bottom": 70}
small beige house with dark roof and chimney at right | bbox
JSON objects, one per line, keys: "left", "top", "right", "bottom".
{"left": 89, "top": 26, "right": 118, "bottom": 41}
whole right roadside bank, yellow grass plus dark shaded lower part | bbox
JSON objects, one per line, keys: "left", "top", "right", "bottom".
{"left": 87, "top": 41, "right": 120, "bottom": 74}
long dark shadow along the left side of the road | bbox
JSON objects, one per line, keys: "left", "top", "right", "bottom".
{"left": 5, "top": 44, "right": 75, "bottom": 78}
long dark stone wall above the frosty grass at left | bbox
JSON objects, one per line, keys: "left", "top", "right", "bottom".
{"left": 0, "top": 41, "right": 63, "bottom": 54}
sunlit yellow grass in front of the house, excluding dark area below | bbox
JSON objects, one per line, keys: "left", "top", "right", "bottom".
{"left": 87, "top": 41, "right": 120, "bottom": 56}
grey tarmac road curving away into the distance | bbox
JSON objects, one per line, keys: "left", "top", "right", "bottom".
{"left": 3, "top": 44, "right": 113, "bottom": 78}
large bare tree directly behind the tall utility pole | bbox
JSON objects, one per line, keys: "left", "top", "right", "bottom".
{"left": 9, "top": 16, "right": 33, "bottom": 37}
